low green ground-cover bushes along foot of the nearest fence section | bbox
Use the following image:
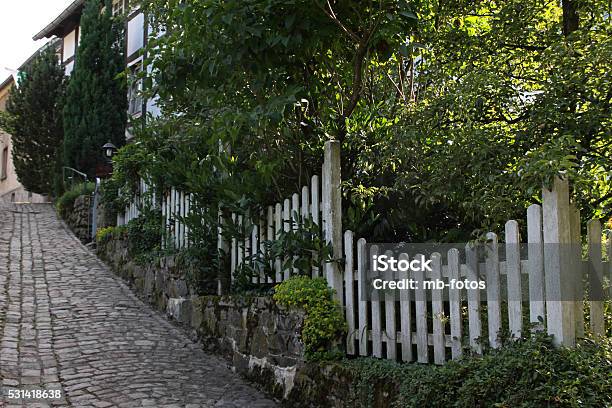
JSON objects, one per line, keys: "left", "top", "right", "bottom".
{"left": 346, "top": 335, "right": 612, "bottom": 407}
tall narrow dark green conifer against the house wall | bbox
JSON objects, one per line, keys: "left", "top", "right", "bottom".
{"left": 64, "top": 0, "right": 127, "bottom": 174}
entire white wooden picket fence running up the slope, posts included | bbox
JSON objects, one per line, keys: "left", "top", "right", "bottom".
{"left": 117, "top": 141, "right": 612, "bottom": 364}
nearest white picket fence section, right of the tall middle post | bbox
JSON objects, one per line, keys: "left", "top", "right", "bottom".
{"left": 343, "top": 192, "right": 612, "bottom": 364}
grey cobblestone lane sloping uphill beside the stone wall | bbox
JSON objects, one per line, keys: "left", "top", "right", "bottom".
{"left": 0, "top": 204, "right": 275, "bottom": 408}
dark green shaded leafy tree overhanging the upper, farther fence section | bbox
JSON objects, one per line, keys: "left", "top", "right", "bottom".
{"left": 137, "top": 0, "right": 415, "bottom": 210}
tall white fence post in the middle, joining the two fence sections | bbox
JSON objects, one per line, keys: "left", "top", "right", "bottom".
{"left": 323, "top": 140, "right": 343, "bottom": 303}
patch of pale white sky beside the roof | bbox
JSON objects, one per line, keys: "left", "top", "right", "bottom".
{"left": 0, "top": 0, "right": 73, "bottom": 83}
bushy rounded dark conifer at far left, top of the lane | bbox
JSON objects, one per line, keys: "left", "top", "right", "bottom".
{"left": 0, "top": 47, "right": 65, "bottom": 195}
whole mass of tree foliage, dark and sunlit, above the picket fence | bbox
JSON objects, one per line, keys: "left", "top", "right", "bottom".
{"left": 137, "top": 0, "right": 612, "bottom": 245}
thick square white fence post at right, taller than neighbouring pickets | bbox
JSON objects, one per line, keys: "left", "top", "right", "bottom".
{"left": 542, "top": 178, "right": 576, "bottom": 346}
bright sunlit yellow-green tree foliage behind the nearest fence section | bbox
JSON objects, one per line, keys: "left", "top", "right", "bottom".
{"left": 388, "top": 0, "right": 612, "bottom": 239}
